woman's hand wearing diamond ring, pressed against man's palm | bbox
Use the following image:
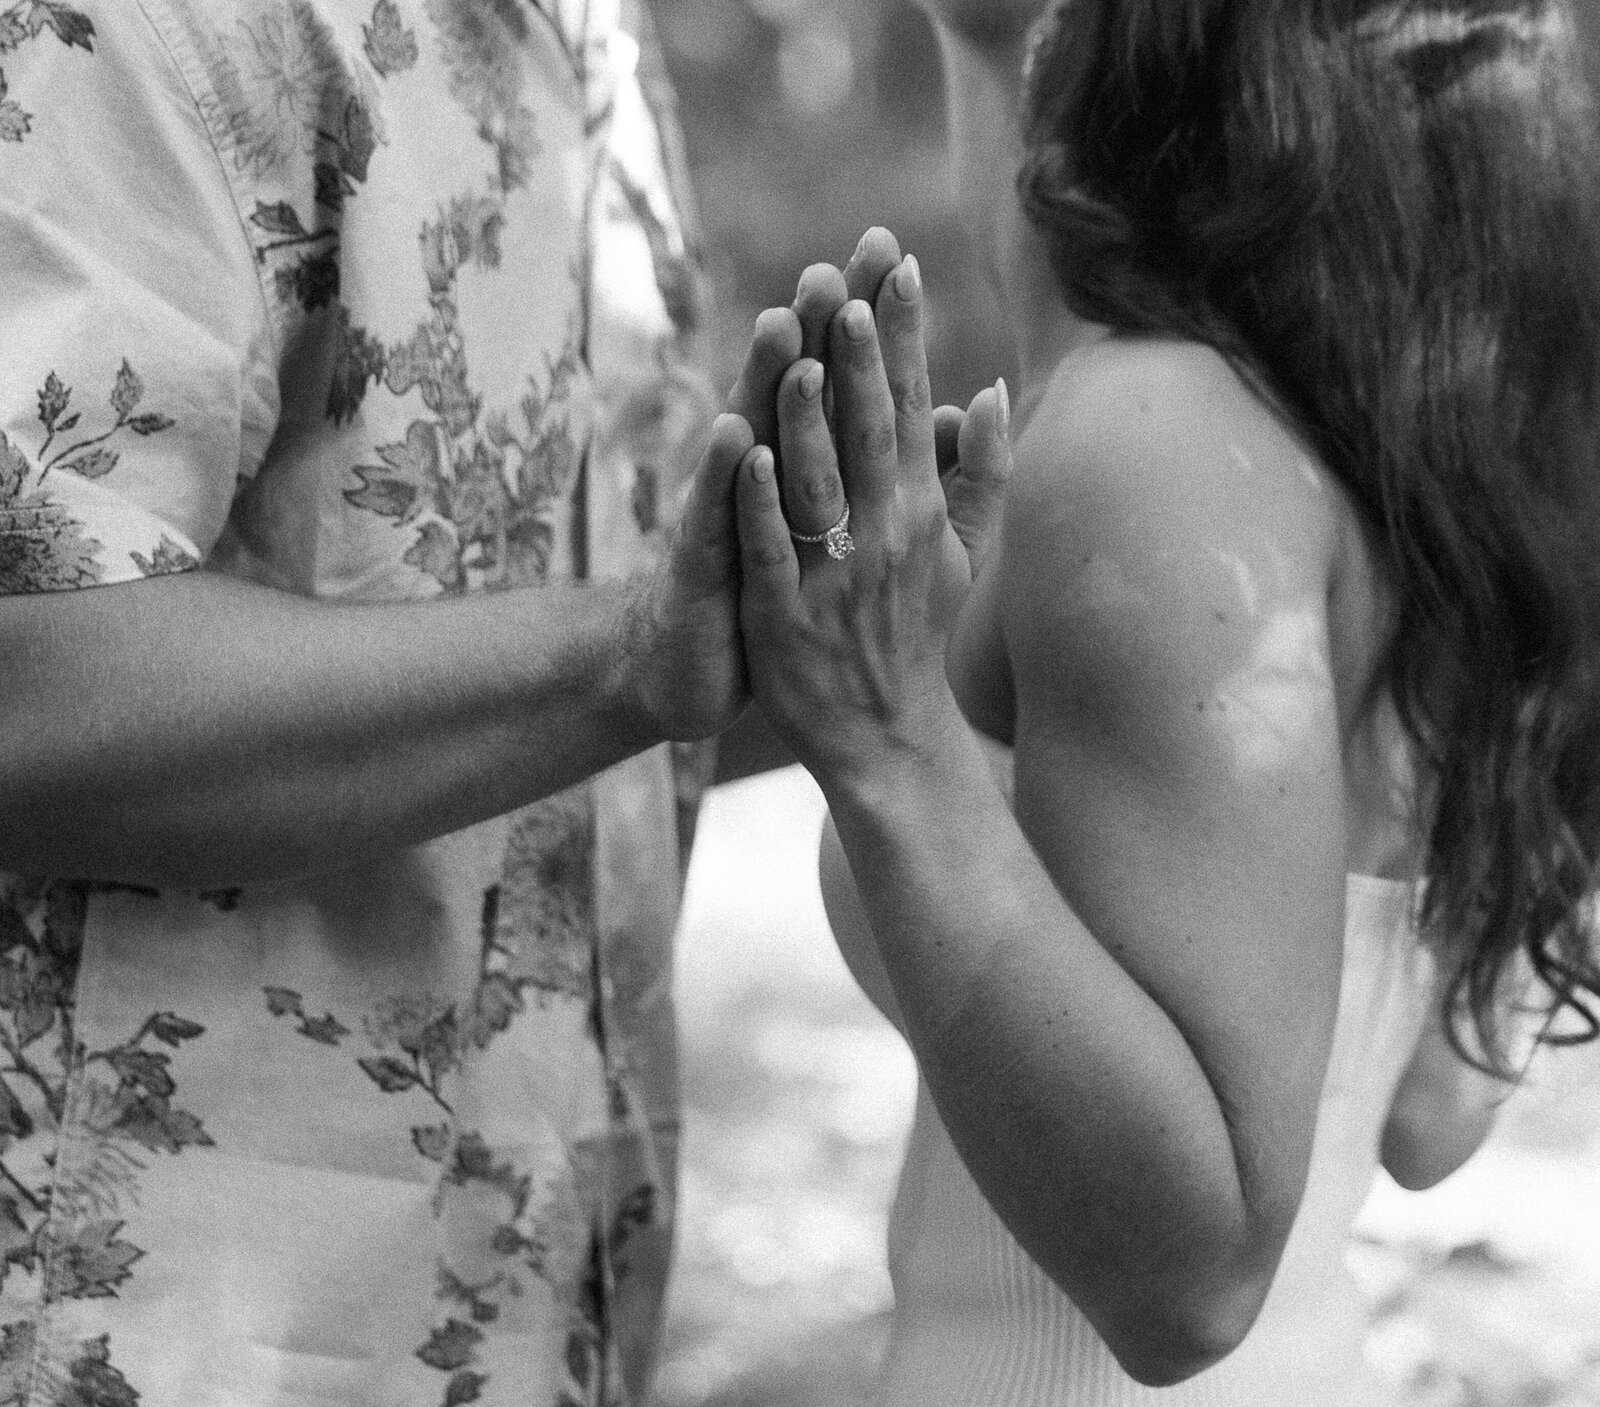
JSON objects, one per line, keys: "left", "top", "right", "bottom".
{"left": 738, "top": 259, "right": 1010, "bottom": 788}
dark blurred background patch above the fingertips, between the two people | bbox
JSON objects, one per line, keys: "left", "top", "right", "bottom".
{"left": 650, "top": 0, "right": 1011, "bottom": 405}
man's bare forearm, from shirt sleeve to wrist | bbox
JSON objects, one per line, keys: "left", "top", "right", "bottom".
{"left": 0, "top": 571, "right": 659, "bottom": 885}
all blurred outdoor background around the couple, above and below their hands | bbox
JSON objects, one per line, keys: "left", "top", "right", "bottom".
{"left": 651, "top": 0, "right": 1600, "bottom": 1407}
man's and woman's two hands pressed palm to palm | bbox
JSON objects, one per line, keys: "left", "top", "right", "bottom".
{"left": 669, "top": 230, "right": 1010, "bottom": 791}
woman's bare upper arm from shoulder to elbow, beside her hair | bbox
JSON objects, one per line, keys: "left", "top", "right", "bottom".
{"left": 997, "top": 348, "right": 1344, "bottom": 1205}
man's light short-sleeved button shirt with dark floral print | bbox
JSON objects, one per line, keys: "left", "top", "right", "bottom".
{"left": 0, "top": 0, "right": 707, "bottom": 1407}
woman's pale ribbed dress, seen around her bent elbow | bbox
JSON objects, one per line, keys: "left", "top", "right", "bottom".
{"left": 877, "top": 876, "right": 1432, "bottom": 1407}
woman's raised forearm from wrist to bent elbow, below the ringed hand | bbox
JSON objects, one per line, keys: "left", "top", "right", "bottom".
{"left": 824, "top": 730, "right": 1304, "bottom": 1383}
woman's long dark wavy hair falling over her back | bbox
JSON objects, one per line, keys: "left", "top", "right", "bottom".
{"left": 1018, "top": 0, "right": 1600, "bottom": 1074}
